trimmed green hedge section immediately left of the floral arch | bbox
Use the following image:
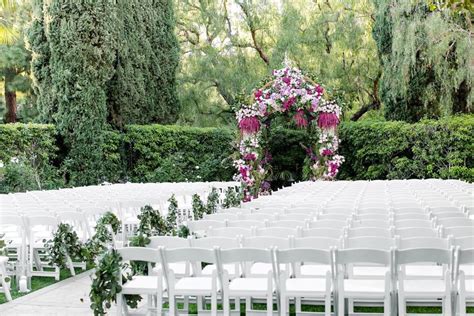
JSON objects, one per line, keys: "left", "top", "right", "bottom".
{"left": 125, "top": 125, "right": 234, "bottom": 182}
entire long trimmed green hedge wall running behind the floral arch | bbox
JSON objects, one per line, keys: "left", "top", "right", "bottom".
{"left": 0, "top": 115, "right": 474, "bottom": 192}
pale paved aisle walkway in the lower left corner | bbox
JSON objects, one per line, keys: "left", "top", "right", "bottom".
{"left": 0, "top": 271, "right": 107, "bottom": 316}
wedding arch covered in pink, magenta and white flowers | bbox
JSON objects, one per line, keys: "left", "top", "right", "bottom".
{"left": 234, "top": 63, "right": 344, "bottom": 201}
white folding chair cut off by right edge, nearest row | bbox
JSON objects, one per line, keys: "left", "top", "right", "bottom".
{"left": 454, "top": 247, "right": 474, "bottom": 316}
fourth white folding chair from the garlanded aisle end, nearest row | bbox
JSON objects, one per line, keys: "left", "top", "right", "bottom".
{"left": 274, "top": 248, "right": 335, "bottom": 315}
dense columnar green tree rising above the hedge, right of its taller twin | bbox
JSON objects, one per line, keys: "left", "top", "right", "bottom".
{"left": 107, "top": 0, "right": 179, "bottom": 127}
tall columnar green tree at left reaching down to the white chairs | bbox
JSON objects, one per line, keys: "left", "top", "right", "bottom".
{"left": 31, "top": 0, "right": 115, "bottom": 185}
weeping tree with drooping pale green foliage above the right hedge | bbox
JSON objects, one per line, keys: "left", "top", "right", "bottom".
{"left": 373, "top": 0, "right": 474, "bottom": 122}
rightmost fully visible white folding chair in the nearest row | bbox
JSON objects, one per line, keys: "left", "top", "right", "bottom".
{"left": 395, "top": 247, "right": 454, "bottom": 316}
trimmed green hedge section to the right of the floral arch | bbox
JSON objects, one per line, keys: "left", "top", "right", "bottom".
{"left": 339, "top": 115, "right": 474, "bottom": 182}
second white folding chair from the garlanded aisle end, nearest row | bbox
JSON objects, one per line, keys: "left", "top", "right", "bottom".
{"left": 159, "top": 247, "right": 220, "bottom": 316}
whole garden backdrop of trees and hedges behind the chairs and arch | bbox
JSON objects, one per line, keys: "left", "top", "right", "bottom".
{"left": 0, "top": 0, "right": 474, "bottom": 192}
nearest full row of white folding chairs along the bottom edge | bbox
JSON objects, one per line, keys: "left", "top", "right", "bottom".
{"left": 117, "top": 248, "right": 473, "bottom": 315}
